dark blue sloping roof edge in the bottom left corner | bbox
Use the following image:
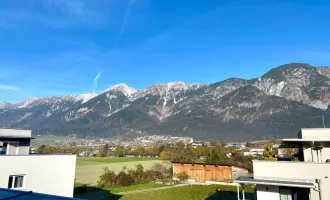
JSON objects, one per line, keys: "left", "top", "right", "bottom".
{"left": 0, "top": 188, "right": 77, "bottom": 200}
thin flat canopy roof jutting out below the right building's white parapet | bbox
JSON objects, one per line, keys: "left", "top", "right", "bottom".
{"left": 234, "top": 176, "right": 315, "bottom": 188}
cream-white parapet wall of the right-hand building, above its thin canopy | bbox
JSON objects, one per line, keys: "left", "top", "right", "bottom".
{"left": 253, "top": 160, "right": 330, "bottom": 200}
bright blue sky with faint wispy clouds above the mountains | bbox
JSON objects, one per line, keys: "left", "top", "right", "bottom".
{"left": 0, "top": 0, "right": 330, "bottom": 103}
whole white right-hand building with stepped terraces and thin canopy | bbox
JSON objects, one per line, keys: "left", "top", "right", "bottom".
{"left": 235, "top": 128, "right": 330, "bottom": 200}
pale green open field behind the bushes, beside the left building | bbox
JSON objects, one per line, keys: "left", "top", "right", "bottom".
{"left": 75, "top": 157, "right": 169, "bottom": 185}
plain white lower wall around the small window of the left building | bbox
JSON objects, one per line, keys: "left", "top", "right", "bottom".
{"left": 0, "top": 155, "right": 76, "bottom": 197}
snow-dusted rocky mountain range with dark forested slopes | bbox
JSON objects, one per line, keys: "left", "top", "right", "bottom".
{"left": 0, "top": 63, "right": 330, "bottom": 141}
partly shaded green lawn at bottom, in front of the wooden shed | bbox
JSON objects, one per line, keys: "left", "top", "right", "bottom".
{"left": 77, "top": 185, "right": 254, "bottom": 200}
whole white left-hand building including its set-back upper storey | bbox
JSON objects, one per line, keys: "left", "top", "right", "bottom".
{"left": 0, "top": 129, "right": 76, "bottom": 197}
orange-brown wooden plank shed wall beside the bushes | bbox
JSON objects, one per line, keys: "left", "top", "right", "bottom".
{"left": 173, "top": 162, "right": 248, "bottom": 183}
